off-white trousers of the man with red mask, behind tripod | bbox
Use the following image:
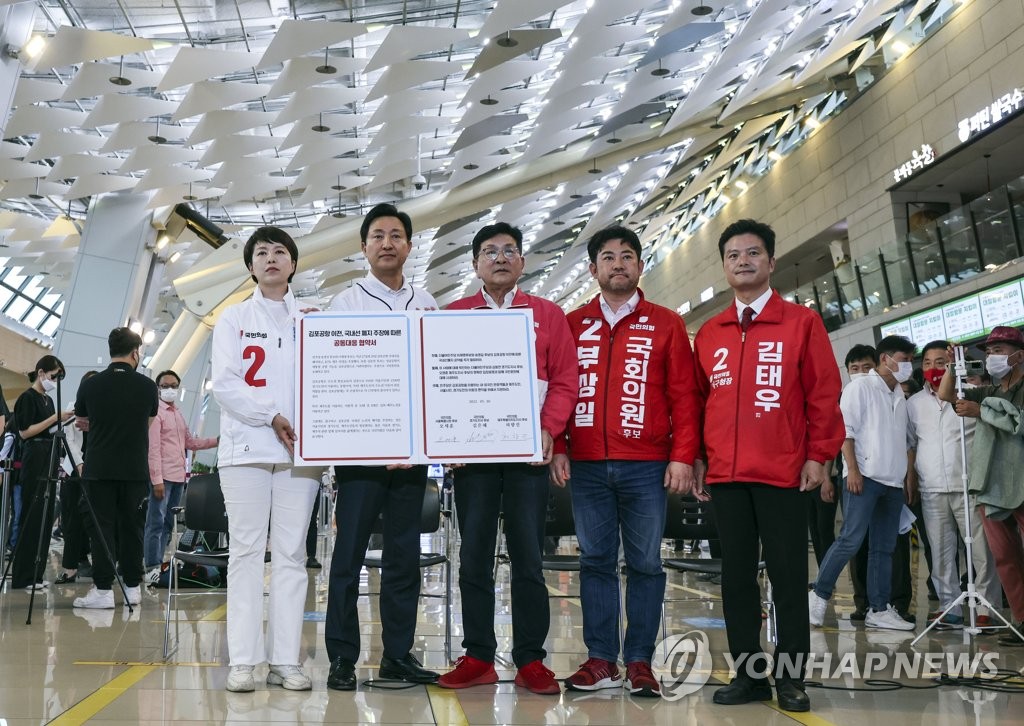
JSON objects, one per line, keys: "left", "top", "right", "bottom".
{"left": 921, "top": 490, "right": 1002, "bottom": 615}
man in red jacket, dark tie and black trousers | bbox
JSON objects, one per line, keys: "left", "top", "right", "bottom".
{"left": 694, "top": 219, "right": 846, "bottom": 711}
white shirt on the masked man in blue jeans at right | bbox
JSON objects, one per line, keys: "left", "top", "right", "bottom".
{"left": 839, "top": 371, "right": 908, "bottom": 488}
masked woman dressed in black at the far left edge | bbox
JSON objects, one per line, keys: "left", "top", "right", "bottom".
{"left": 11, "top": 355, "right": 72, "bottom": 590}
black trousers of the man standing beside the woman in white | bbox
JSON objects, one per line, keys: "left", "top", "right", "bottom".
{"left": 325, "top": 466, "right": 427, "bottom": 663}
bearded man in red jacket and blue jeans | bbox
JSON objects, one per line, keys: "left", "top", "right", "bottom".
{"left": 552, "top": 227, "right": 700, "bottom": 696}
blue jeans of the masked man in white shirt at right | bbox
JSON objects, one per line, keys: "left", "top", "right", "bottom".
{"left": 814, "top": 476, "right": 903, "bottom": 612}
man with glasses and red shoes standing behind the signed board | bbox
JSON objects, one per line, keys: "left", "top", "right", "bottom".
{"left": 437, "top": 222, "right": 577, "bottom": 695}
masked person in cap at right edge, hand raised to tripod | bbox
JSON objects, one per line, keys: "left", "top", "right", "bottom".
{"left": 939, "top": 326, "right": 1024, "bottom": 646}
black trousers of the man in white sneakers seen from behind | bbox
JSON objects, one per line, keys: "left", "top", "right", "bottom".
{"left": 82, "top": 479, "right": 150, "bottom": 590}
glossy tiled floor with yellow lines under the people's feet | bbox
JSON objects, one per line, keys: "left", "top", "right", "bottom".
{"left": 0, "top": 539, "right": 1024, "bottom": 726}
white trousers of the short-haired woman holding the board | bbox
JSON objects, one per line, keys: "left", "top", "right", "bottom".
{"left": 220, "top": 464, "right": 323, "bottom": 666}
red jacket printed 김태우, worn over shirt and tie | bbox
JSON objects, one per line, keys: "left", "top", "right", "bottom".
{"left": 693, "top": 292, "right": 846, "bottom": 487}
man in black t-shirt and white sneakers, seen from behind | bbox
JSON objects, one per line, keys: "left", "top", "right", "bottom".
{"left": 74, "top": 328, "right": 157, "bottom": 608}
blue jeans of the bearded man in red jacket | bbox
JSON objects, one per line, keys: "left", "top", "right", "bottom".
{"left": 570, "top": 461, "right": 668, "bottom": 664}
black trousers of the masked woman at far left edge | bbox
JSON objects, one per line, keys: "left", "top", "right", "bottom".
{"left": 11, "top": 436, "right": 56, "bottom": 588}
